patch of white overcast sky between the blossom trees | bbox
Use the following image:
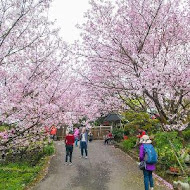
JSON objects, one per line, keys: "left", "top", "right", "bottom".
{"left": 49, "top": 0, "right": 89, "bottom": 43}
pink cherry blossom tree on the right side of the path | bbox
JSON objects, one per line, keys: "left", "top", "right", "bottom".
{"left": 76, "top": 0, "right": 190, "bottom": 130}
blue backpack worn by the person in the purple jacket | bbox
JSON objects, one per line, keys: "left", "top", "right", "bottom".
{"left": 143, "top": 144, "right": 158, "bottom": 164}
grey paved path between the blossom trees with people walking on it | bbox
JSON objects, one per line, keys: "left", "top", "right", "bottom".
{"left": 34, "top": 141, "right": 170, "bottom": 190}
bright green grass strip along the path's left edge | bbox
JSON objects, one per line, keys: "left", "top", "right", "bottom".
{"left": 0, "top": 145, "right": 54, "bottom": 190}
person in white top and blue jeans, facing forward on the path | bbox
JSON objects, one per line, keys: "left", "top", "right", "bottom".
{"left": 80, "top": 127, "right": 88, "bottom": 158}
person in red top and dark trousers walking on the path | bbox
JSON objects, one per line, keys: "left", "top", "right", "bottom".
{"left": 65, "top": 131, "right": 75, "bottom": 165}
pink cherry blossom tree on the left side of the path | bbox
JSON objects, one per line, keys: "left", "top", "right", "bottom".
{"left": 0, "top": 0, "right": 82, "bottom": 157}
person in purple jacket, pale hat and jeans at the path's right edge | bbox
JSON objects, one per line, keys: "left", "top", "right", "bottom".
{"left": 139, "top": 135, "right": 157, "bottom": 190}
